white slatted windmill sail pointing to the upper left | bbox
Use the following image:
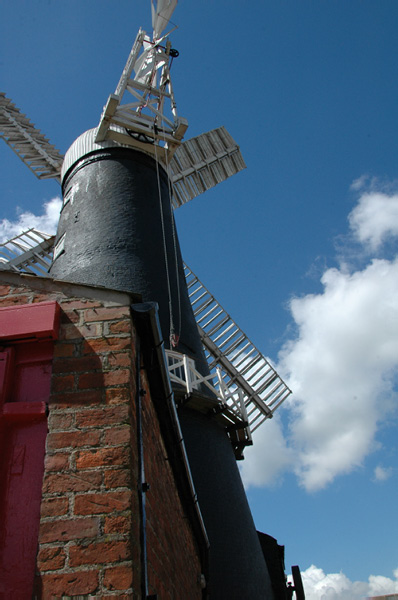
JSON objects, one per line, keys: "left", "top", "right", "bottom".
{"left": 0, "top": 92, "right": 63, "bottom": 181}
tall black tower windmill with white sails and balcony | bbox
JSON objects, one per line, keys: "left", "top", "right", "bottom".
{"left": 0, "top": 0, "right": 290, "bottom": 598}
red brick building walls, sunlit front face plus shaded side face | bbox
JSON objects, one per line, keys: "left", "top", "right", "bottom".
{"left": 0, "top": 274, "right": 202, "bottom": 600}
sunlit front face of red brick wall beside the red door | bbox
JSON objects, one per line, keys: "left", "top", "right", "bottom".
{"left": 0, "top": 278, "right": 140, "bottom": 599}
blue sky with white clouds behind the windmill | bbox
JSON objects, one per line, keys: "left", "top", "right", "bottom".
{"left": 0, "top": 0, "right": 398, "bottom": 600}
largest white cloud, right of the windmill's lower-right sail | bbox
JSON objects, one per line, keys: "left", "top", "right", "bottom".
{"left": 279, "top": 255, "right": 398, "bottom": 490}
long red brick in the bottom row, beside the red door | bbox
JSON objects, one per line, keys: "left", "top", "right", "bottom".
{"left": 41, "top": 569, "right": 98, "bottom": 600}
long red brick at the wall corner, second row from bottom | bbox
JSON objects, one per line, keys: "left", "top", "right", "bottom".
{"left": 69, "top": 541, "right": 130, "bottom": 567}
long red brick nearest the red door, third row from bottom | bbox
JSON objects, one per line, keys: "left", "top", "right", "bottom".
{"left": 39, "top": 517, "right": 99, "bottom": 544}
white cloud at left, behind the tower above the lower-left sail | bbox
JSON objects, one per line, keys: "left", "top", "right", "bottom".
{"left": 0, "top": 198, "right": 62, "bottom": 243}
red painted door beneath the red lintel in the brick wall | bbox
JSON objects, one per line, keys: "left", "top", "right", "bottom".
{"left": 0, "top": 303, "right": 59, "bottom": 600}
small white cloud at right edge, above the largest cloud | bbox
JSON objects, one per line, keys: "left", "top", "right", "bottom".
{"left": 349, "top": 191, "right": 398, "bottom": 252}
